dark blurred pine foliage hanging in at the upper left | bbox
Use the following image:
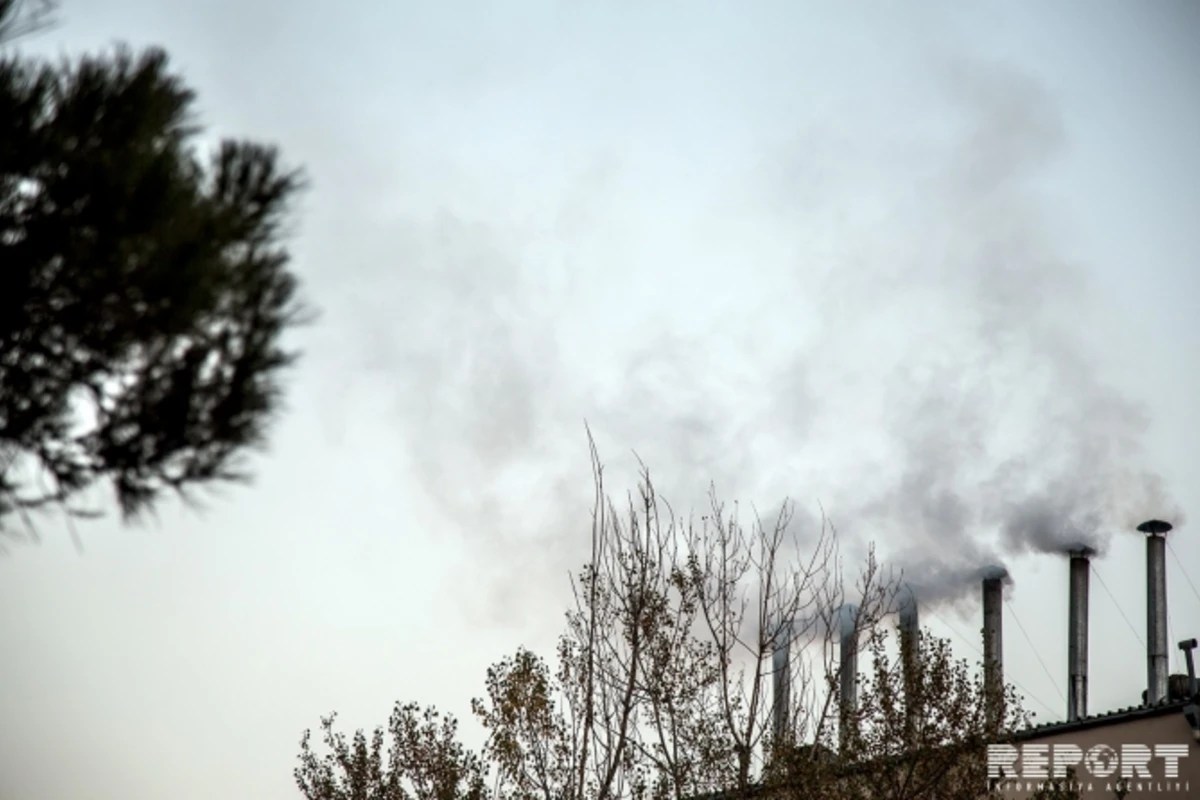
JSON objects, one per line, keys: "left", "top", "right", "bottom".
{"left": 0, "top": 23, "right": 302, "bottom": 530}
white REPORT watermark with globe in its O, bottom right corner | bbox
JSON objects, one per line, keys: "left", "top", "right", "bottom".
{"left": 988, "top": 744, "right": 1190, "bottom": 794}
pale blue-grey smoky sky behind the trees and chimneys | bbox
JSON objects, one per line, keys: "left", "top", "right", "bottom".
{"left": 0, "top": 0, "right": 1200, "bottom": 800}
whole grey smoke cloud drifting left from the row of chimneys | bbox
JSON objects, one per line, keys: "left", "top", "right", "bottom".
{"left": 340, "top": 54, "right": 1182, "bottom": 621}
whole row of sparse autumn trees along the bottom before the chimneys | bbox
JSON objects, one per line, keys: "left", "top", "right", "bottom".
{"left": 298, "top": 450, "right": 1028, "bottom": 800}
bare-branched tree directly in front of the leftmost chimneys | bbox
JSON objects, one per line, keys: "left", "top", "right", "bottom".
{"left": 686, "top": 494, "right": 888, "bottom": 792}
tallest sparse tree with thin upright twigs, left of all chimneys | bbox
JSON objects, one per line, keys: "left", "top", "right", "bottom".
{"left": 474, "top": 449, "right": 705, "bottom": 800}
